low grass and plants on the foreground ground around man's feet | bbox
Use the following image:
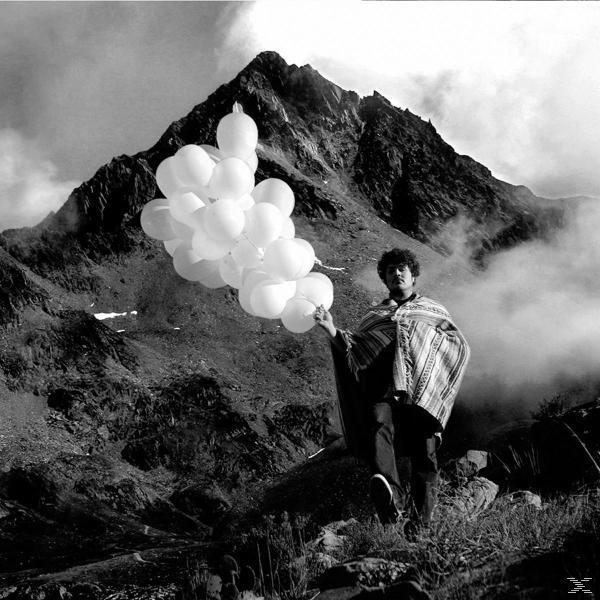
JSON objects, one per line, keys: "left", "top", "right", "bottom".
{"left": 204, "top": 487, "right": 600, "bottom": 600}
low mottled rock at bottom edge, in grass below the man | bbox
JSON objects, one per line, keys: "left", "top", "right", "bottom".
{"left": 318, "top": 557, "right": 410, "bottom": 590}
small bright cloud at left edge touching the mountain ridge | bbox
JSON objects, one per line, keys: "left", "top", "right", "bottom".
{"left": 0, "top": 129, "right": 78, "bottom": 231}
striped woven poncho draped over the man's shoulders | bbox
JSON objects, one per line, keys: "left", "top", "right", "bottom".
{"left": 332, "top": 294, "right": 470, "bottom": 454}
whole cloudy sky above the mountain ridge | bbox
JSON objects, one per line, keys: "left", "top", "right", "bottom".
{"left": 0, "top": 0, "right": 600, "bottom": 230}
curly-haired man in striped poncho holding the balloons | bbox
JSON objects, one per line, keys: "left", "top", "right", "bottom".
{"left": 314, "top": 248, "right": 469, "bottom": 537}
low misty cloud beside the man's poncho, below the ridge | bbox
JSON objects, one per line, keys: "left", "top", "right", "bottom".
{"left": 444, "top": 200, "right": 600, "bottom": 410}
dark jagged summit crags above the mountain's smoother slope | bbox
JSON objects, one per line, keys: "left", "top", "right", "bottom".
{"left": 6, "top": 52, "right": 562, "bottom": 264}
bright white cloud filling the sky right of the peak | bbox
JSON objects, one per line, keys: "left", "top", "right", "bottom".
{"left": 233, "top": 2, "right": 600, "bottom": 197}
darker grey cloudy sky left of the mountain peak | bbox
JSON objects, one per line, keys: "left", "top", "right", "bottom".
{"left": 0, "top": 2, "right": 250, "bottom": 180}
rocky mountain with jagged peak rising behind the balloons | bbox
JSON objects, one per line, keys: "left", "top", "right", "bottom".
{"left": 0, "top": 53, "right": 584, "bottom": 592}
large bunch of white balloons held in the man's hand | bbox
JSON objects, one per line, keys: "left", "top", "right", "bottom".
{"left": 141, "top": 103, "right": 333, "bottom": 333}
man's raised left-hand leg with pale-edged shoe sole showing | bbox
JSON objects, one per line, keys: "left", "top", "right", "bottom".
{"left": 370, "top": 402, "right": 400, "bottom": 524}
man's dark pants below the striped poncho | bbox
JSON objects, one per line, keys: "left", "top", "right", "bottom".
{"left": 371, "top": 400, "right": 439, "bottom": 525}
